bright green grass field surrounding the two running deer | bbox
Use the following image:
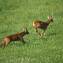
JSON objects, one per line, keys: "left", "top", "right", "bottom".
{"left": 0, "top": 0, "right": 63, "bottom": 63}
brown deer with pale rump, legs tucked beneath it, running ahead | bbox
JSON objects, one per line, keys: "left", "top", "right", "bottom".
{"left": 33, "top": 16, "right": 53, "bottom": 36}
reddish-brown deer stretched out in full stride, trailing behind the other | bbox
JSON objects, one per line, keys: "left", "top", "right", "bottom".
{"left": 0, "top": 28, "right": 29, "bottom": 47}
